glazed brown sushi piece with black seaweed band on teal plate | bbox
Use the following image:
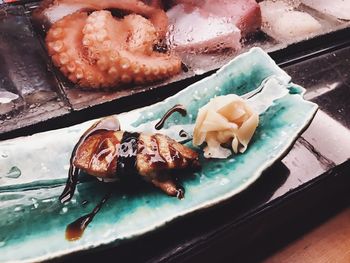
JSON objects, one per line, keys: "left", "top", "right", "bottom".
{"left": 60, "top": 117, "right": 200, "bottom": 202}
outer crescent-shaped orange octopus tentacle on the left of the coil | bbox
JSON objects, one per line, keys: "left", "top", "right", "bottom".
{"left": 46, "top": 13, "right": 114, "bottom": 88}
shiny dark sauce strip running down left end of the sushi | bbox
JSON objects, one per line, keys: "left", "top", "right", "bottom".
{"left": 59, "top": 116, "right": 120, "bottom": 203}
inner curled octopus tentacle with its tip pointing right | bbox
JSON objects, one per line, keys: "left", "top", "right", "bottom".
{"left": 83, "top": 11, "right": 181, "bottom": 83}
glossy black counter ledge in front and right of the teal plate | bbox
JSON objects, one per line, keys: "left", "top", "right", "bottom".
{"left": 64, "top": 37, "right": 350, "bottom": 262}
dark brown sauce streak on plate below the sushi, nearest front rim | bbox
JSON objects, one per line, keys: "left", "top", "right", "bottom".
{"left": 66, "top": 192, "right": 111, "bottom": 241}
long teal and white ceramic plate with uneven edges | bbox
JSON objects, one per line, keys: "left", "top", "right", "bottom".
{"left": 0, "top": 48, "right": 317, "bottom": 262}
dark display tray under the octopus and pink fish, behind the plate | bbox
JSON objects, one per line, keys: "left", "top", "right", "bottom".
{"left": 0, "top": 0, "right": 350, "bottom": 139}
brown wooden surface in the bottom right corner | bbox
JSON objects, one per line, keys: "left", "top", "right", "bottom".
{"left": 263, "top": 208, "right": 350, "bottom": 263}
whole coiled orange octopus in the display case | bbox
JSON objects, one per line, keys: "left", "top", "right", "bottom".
{"left": 35, "top": 0, "right": 181, "bottom": 88}
